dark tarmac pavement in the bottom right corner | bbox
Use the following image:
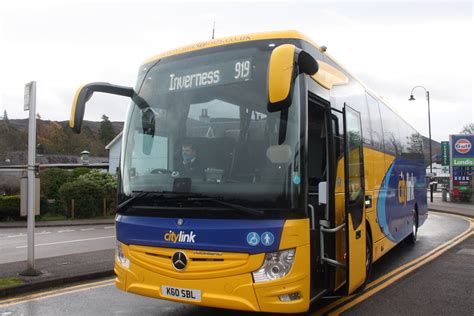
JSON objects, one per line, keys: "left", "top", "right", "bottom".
{"left": 343, "top": 235, "right": 474, "bottom": 315}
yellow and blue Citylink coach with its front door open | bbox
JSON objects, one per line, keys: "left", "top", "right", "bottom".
{"left": 70, "top": 31, "right": 427, "bottom": 313}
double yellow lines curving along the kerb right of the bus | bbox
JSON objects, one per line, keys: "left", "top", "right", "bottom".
{"left": 313, "top": 213, "right": 474, "bottom": 315}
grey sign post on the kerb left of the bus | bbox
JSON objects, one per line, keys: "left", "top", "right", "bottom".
{"left": 20, "top": 81, "right": 41, "bottom": 276}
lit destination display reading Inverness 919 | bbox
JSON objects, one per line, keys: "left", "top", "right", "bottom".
{"left": 157, "top": 58, "right": 253, "bottom": 94}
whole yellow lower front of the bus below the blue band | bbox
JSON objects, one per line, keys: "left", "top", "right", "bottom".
{"left": 114, "top": 219, "right": 310, "bottom": 313}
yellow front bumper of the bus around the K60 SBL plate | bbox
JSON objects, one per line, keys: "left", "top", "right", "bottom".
{"left": 114, "top": 245, "right": 310, "bottom": 313}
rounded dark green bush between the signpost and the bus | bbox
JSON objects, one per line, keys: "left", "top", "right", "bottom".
{"left": 58, "top": 177, "right": 106, "bottom": 218}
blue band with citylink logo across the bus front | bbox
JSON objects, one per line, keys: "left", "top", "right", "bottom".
{"left": 116, "top": 215, "right": 285, "bottom": 254}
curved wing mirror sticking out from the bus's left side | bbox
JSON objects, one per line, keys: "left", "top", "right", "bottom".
{"left": 69, "top": 82, "right": 135, "bottom": 134}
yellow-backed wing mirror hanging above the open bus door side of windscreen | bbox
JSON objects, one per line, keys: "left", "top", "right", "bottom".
{"left": 267, "top": 44, "right": 318, "bottom": 112}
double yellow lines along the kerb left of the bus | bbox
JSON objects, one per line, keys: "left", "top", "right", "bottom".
{"left": 0, "top": 279, "right": 114, "bottom": 308}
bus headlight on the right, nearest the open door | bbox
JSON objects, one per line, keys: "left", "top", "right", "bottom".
{"left": 252, "top": 248, "right": 295, "bottom": 283}
